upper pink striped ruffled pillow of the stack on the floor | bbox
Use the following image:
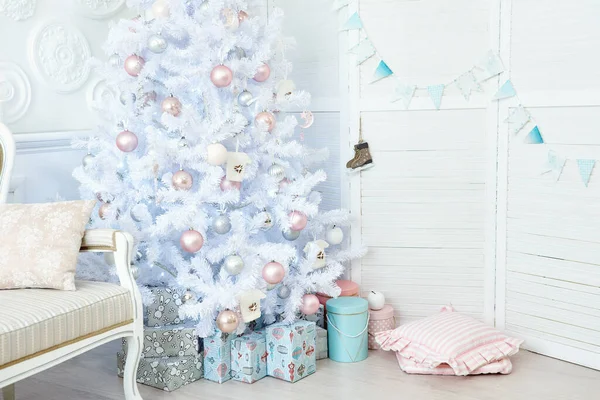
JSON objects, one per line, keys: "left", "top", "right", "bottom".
{"left": 375, "top": 308, "right": 523, "bottom": 375}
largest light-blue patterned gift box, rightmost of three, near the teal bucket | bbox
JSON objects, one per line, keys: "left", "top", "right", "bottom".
{"left": 267, "top": 321, "right": 317, "bottom": 382}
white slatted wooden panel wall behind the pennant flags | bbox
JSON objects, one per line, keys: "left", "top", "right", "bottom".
{"left": 341, "top": 0, "right": 600, "bottom": 369}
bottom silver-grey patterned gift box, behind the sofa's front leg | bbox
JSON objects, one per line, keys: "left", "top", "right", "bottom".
{"left": 117, "top": 353, "right": 202, "bottom": 392}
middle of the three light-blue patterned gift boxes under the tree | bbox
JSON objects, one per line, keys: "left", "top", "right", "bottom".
{"left": 231, "top": 331, "right": 268, "bottom": 383}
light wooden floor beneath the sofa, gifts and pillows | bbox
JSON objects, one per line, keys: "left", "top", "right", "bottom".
{"left": 5, "top": 343, "right": 600, "bottom": 400}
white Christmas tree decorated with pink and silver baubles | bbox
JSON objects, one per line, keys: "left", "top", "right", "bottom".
{"left": 74, "top": 0, "right": 362, "bottom": 336}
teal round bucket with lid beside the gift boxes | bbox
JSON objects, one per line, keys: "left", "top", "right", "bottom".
{"left": 327, "top": 297, "right": 369, "bottom": 363}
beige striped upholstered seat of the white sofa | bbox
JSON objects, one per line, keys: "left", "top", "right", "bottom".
{"left": 0, "top": 281, "right": 133, "bottom": 370}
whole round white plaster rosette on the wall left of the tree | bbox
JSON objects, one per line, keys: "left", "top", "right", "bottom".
{"left": 31, "top": 22, "right": 91, "bottom": 93}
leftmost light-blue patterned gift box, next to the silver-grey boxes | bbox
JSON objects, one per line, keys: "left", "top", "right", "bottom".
{"left": 204, "top": 331, "right": 235, "bottom": 383}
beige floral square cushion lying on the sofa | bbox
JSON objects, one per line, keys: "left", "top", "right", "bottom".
{"left": 0, "top": 201, "right": 96, "bottom": 290}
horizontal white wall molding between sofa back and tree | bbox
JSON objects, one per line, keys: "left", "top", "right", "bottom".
{"left": 14, "top": 130, "right": 89, "bottom": 154}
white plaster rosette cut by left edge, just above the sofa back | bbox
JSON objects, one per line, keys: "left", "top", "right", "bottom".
{"left": 0, "top": 62, "right": 31, "bottom": 123}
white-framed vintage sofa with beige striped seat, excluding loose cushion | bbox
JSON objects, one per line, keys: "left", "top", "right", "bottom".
{"left": 0, "top": 123, "right": 143, "bottom": 400}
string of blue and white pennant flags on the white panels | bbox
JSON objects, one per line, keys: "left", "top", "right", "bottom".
{"left": 332, "top": 0, "right": 596, "bottom": 187}
